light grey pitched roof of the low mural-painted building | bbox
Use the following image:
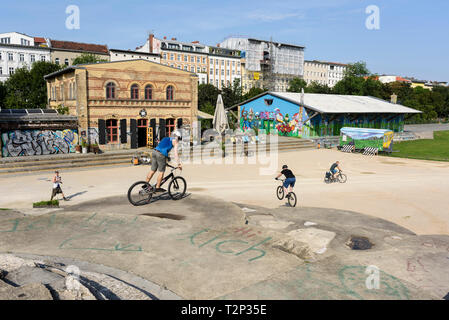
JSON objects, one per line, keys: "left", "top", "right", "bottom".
{"left": 231, "top": 92, "right": 421, "bottom": 113}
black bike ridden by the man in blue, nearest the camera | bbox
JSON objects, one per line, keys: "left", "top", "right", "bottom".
{"left": 128, "top": 164, "right": 187, "bottom": 206}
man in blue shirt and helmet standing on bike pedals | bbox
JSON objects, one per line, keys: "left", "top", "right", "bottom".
{"left": 147, "top": 130, "right": 182, "bottom": 192}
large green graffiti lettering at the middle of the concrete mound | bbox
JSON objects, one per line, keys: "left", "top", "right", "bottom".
{"left": 176, "top": 229, "right": 272, "bottom": 262}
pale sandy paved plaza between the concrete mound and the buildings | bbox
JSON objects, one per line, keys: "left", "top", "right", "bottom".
{"left": 0, "top": 149, "right": 449, "bottom": 235}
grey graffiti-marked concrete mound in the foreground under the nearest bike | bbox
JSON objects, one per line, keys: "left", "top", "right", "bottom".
{"left": 0, "top": 195, "right": 449, "bottom": 299}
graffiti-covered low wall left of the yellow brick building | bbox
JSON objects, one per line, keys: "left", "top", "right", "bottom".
{"left": 1, "top": 129, "right": 78, "bottom": 157}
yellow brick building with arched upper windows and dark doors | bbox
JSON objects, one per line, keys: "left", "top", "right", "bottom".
{"left": 45, "top": 60, "right": 198, "bottom": 150}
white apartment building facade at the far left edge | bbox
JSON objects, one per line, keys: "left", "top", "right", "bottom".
{"left": 0, "top": 32, "right": 50, "bottom": 82}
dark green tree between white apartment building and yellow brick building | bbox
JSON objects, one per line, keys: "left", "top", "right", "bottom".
{"left": 5, "top": 61, "right": 60, "bottom": 109}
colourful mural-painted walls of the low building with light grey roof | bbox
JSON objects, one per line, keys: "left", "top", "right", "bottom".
{"left": 240, "top": 94, "right": 404, "bottom": 138}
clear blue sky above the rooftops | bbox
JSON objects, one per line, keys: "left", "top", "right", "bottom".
{"left": 0, "top": 0, "right": 449, "bottom": 81}
